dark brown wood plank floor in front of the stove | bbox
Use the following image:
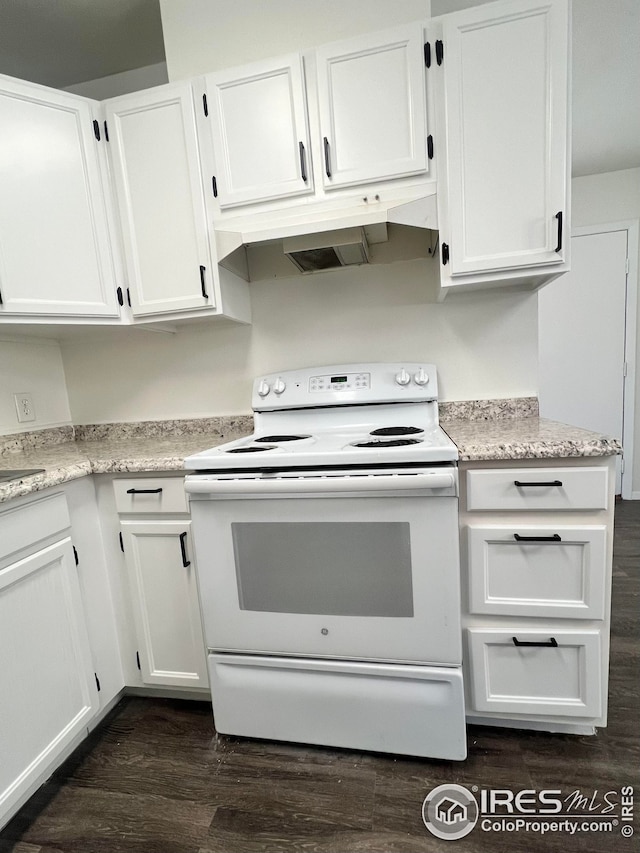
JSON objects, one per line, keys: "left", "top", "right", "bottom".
{"left": 0, "top": 502, "right": 640, "bottom": 853}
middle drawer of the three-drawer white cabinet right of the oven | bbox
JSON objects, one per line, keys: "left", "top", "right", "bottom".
{"left": 467, "top": 524, "right": 607, "bottom": 619}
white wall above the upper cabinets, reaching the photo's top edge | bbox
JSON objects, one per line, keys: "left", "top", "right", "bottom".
{"left": 160, "top": 0, "right": 431, "bottom": 80}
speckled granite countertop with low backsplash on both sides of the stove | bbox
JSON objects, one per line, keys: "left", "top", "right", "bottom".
{"left": 0, "top": 398, "right": 621, "bottom": 503}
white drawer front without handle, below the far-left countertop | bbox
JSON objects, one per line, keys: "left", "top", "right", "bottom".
{"left": 0, "top": 494, "right": 71, "bottom": 560}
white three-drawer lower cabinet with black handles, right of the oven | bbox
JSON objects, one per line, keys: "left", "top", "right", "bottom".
{"left": 460, "top": 457, "right": 614, "bottom": 733}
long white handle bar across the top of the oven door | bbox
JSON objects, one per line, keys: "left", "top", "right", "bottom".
{"left": 185, "top": 471, "right": 456, "bottom": 499}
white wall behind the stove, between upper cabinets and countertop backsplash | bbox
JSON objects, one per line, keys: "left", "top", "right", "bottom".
{"left": 62, "top": 260, "right": 537, "bottom": 423}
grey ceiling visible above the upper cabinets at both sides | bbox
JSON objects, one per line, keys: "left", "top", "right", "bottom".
{"left": 0, "top": 0, "right": 640, "bottom": 175}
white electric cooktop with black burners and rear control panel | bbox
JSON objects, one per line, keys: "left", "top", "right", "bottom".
{"left": 185, "top": 363, "right": 458, "bottom": 470}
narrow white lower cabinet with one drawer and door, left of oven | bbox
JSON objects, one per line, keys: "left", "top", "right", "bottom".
{"left": 113, "top": 477, "right": 209, "bottom": 689}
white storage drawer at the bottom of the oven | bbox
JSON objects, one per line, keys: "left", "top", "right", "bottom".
{"left": 209, "top": 654, "right": 466, "bottom": 761}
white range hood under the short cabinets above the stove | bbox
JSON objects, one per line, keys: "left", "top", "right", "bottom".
{"left": 215, "top": 187, "right": 438, "bottom": 281}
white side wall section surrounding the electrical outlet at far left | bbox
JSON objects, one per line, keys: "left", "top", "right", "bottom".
{"left": 0, "top": 336, "right": 71, "bottom": 435}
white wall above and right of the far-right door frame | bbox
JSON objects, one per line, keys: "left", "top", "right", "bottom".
{"left": 572, "top": 168, "right": 640, "bottom": 492}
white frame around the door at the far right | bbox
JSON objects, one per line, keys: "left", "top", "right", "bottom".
{"left": 571, "top": 219, "right": 640, "bottom": 500}
